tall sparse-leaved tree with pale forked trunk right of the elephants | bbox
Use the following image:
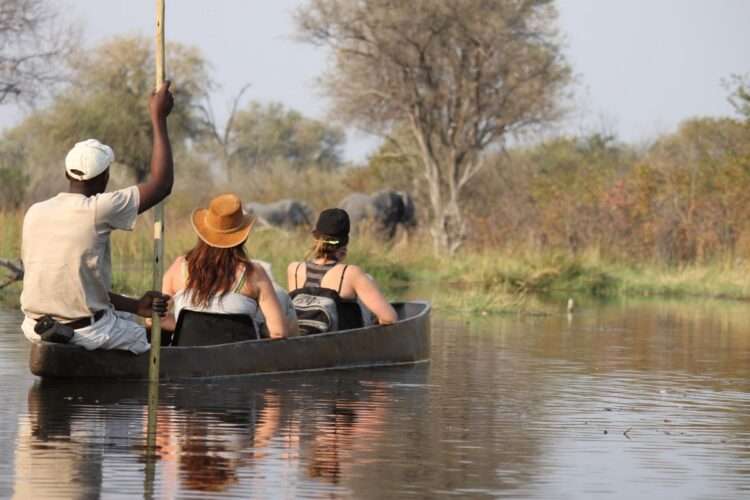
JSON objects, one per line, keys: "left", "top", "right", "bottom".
{"left": 297, "top": 0, "right": 570, "bottom": 253}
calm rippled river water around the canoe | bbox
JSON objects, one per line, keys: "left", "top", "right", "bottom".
{"left": 0, "top": 302, "right": 750, "bottom": 499}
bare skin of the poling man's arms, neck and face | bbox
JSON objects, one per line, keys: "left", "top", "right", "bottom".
{"left": 65, "top": 82, "right": 174, "bottom": 318}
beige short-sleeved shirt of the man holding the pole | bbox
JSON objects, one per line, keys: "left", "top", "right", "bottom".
{"left": 21, "top": 186, "right": 139, "bottom": 321}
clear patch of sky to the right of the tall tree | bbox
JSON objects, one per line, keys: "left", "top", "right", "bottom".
{"left": 558, "top": 0, "right": 750, "bottom": 142}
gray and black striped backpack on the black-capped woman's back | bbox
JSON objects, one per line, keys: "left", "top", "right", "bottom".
{"left": 289, "top": 287, "right": 340, "bottom": 335}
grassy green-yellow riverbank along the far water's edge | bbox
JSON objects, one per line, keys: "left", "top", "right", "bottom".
{"left": 0, "top": 213, "right": 750, "bottom": 312}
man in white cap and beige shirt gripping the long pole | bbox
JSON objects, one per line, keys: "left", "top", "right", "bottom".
{"left": 21, "top": 82, "right": 174, "bottom": 354}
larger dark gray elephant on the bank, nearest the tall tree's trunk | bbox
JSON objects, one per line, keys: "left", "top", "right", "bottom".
{"left": 339, "top": 190, "right": 417, "bottom": 239}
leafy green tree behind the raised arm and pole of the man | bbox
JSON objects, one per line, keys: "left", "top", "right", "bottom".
{"left": 43, "top": 37, "right": 212, "bottom": 182}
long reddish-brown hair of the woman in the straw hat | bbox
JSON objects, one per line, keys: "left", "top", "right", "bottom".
{"left": 185, "top": 239, "right": 253, "bottom": 306}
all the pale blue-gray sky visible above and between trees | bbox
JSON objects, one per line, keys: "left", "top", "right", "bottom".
{"left": 0, "top": 0, "right": 750, "bottom": 161}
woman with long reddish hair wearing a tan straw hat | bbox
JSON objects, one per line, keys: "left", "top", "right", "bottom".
{"left": 162, "top": 194, "right": 287, "bottom": 338}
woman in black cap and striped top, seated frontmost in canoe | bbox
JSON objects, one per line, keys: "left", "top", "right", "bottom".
{"left": 287, "top": 208, "right": 398, "bottom": 334}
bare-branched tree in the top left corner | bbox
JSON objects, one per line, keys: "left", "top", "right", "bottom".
{"left": 0, "top": 0, "right": 78, "bottom": 104}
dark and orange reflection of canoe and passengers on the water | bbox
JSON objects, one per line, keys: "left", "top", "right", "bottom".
{"left": 15, "top": 366, "right": 428, "bottom": 498}
